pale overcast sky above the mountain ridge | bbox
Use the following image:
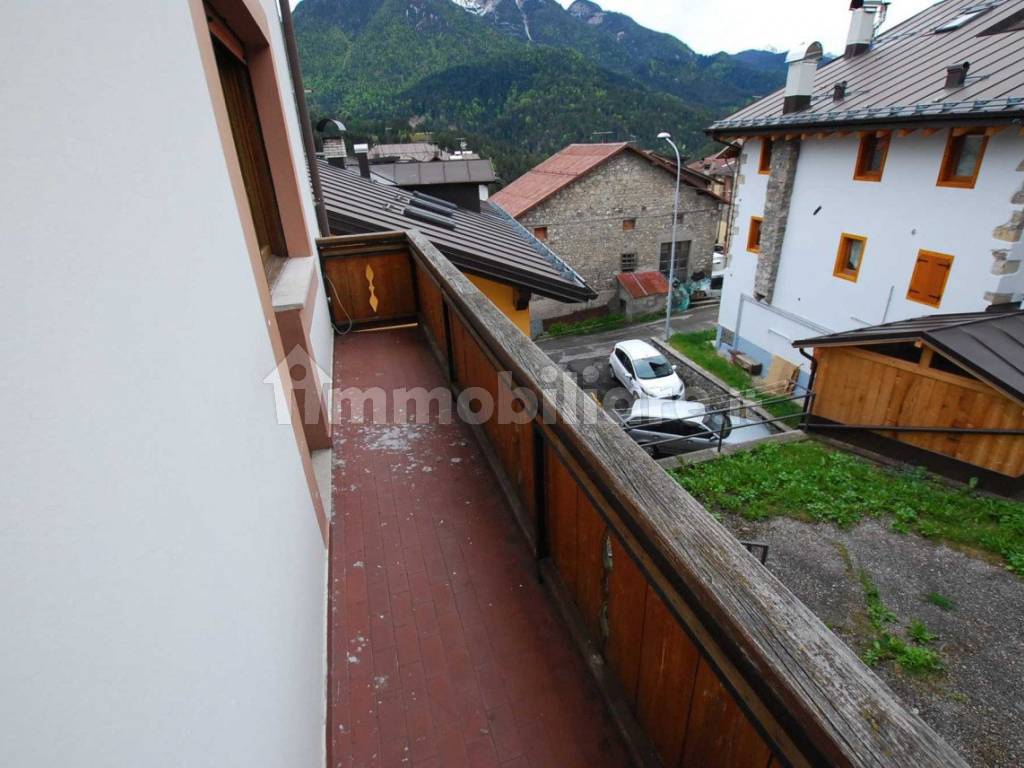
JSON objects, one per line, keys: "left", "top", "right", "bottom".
{"left": 558, "top": 0, "right": 935, "bottom": 53}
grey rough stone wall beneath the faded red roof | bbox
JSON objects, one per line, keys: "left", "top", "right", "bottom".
{"left": 519, "top": 153, "right": 720, "bottom": 325}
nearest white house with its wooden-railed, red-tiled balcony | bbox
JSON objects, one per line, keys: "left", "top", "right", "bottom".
{"left": 0, "top": 0, "right": 965, "bottom": 768}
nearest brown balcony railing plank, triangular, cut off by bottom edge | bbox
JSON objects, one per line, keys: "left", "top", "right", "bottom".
{"left": 680, "top": 659, "right": 772, "bottom": 768}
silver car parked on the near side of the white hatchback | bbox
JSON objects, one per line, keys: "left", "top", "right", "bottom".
{"left": 623, "top": 398, "right": 732, "bottom": 458}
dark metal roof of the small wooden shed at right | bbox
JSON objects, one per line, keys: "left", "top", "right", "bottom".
{"left": 793, "top": 311, "right": 1024, "bottom": 401}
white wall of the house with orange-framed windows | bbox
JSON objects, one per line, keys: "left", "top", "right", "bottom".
{"left": 720, "top": 128, "right": 1024, "bottom": 372}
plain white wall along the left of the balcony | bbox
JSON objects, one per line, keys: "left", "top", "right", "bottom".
{"left": 0, "top": 0, "right": 325, "bottom": 768}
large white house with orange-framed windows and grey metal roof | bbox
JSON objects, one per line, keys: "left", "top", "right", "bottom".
{"left": 710, "top": 0, "right": 1024, "bottom": 382}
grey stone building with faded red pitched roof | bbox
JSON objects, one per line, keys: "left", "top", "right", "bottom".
{"left": 492, "top": 143, "right": 721, "bottom": 331}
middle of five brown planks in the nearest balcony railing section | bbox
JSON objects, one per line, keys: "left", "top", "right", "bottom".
{"left": 605, "top": 537, "right": 647, "bottom": 712}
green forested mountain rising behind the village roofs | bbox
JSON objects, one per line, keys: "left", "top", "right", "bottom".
{"left": 295, "top": 0, "right": 784, "bottom": 181}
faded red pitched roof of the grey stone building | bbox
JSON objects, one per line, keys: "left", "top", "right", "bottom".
{"left": 490, "top": 141, "right": 717, "bottom": 218}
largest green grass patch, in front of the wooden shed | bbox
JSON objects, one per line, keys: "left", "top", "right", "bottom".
{"left": 672, "top": 441, "right": 1024, "bottom": 573}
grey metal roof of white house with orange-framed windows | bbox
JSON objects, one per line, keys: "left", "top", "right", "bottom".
{"left": 709, "top": 0, "right": 1024, "bottom": 135}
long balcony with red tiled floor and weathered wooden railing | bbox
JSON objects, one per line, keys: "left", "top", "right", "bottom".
{"left": 321, "top": 232, "right": 965, "bottom": 768}
